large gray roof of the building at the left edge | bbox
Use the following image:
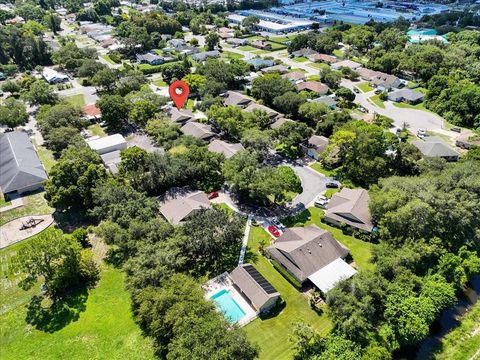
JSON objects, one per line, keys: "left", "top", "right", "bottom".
{"left": 0, "top": 131, "right": 48, "bottom": 193}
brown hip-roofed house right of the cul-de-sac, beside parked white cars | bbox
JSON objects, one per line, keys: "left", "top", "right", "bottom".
{"left": 324, "top": 188, "right": 373, "bottom": 232}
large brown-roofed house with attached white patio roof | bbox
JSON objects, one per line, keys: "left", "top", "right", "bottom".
{"left": 267, "top": 224, "right": 356, "bottom": 293}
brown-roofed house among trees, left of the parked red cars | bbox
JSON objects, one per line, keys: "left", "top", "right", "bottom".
{"left": 160, "top": 191, "right": 212, "bottom": 225}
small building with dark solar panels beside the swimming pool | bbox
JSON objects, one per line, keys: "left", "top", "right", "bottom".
{"left": 230, "top": 263, "right": 280, "bottom": 313}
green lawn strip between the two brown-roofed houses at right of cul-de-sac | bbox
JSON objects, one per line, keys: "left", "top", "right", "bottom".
{"left": 282, "top": 207, "right": 375, "bottom": 269}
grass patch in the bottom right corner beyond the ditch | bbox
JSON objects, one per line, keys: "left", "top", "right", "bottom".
{"left": 433, "top": 301, "right": 480, "bottom": 360}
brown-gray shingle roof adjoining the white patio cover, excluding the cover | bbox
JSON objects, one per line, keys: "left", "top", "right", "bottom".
{"left": 267, "top": 225, "right": 349, "bottom": 283}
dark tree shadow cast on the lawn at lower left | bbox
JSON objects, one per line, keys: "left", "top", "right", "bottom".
{"left": 26, "top": 287, "right": 88, "bottom": 333}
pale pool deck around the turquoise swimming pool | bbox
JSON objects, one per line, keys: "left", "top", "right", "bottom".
{"left": 202, "top": 272, "right": 258, "bottom": 327}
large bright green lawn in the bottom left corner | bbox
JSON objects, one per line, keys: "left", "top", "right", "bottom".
{"left": 0, "top": 267, "right": 155, "bottom": 360}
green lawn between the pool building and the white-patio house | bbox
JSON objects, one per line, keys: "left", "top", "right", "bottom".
{"left": 244, "top": 226, "right": 331, "bottom": 360}
